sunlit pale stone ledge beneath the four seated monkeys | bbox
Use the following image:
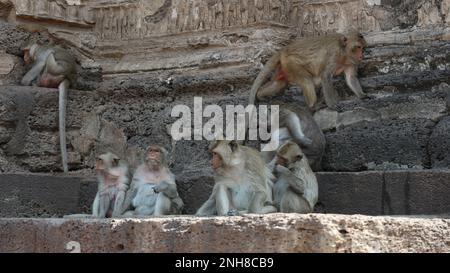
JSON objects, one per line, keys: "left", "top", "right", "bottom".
{"left": 0, "top": 214, "right": 450, "bottom": 253}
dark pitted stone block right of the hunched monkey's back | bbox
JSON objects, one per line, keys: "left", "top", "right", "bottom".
{"left": 322, "top": 119, "right": 434, "bottom": 171}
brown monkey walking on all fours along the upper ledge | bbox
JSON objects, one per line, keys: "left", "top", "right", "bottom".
{"left": 249, "top": 31, "right": 367, "bottom": 108}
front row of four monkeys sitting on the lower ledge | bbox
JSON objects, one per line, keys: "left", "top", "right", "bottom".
{"left": 89, "top": 140, "right": 318, "bottom": 218}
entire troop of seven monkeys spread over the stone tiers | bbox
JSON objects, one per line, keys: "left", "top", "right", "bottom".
{"left": 22, "top": 31, "right": 367, "bottom": 217}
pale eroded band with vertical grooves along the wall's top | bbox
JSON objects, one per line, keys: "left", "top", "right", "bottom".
{"left": 89, "top": 0, "right": 379, "bottom": 40}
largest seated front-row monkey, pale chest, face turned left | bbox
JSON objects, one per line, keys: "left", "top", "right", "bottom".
{"left": 196, "top": 140, "right": 276, "bottom": 216}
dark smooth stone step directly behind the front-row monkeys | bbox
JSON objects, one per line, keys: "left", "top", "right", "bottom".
{"left": 0, "top": 170, "right": 450, "bottom": 217}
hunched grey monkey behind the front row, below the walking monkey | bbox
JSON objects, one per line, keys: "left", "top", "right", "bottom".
{"left": 262, "top": 102, "right": 326, "bottom": 171}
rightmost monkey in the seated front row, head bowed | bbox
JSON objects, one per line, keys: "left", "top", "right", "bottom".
{"left": 271, "top": 141, "right": 319, "bottom": 213}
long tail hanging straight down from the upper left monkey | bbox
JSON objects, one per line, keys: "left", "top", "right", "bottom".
{"left": 58, "top": 79, "right": 70, "bottom": 173}
